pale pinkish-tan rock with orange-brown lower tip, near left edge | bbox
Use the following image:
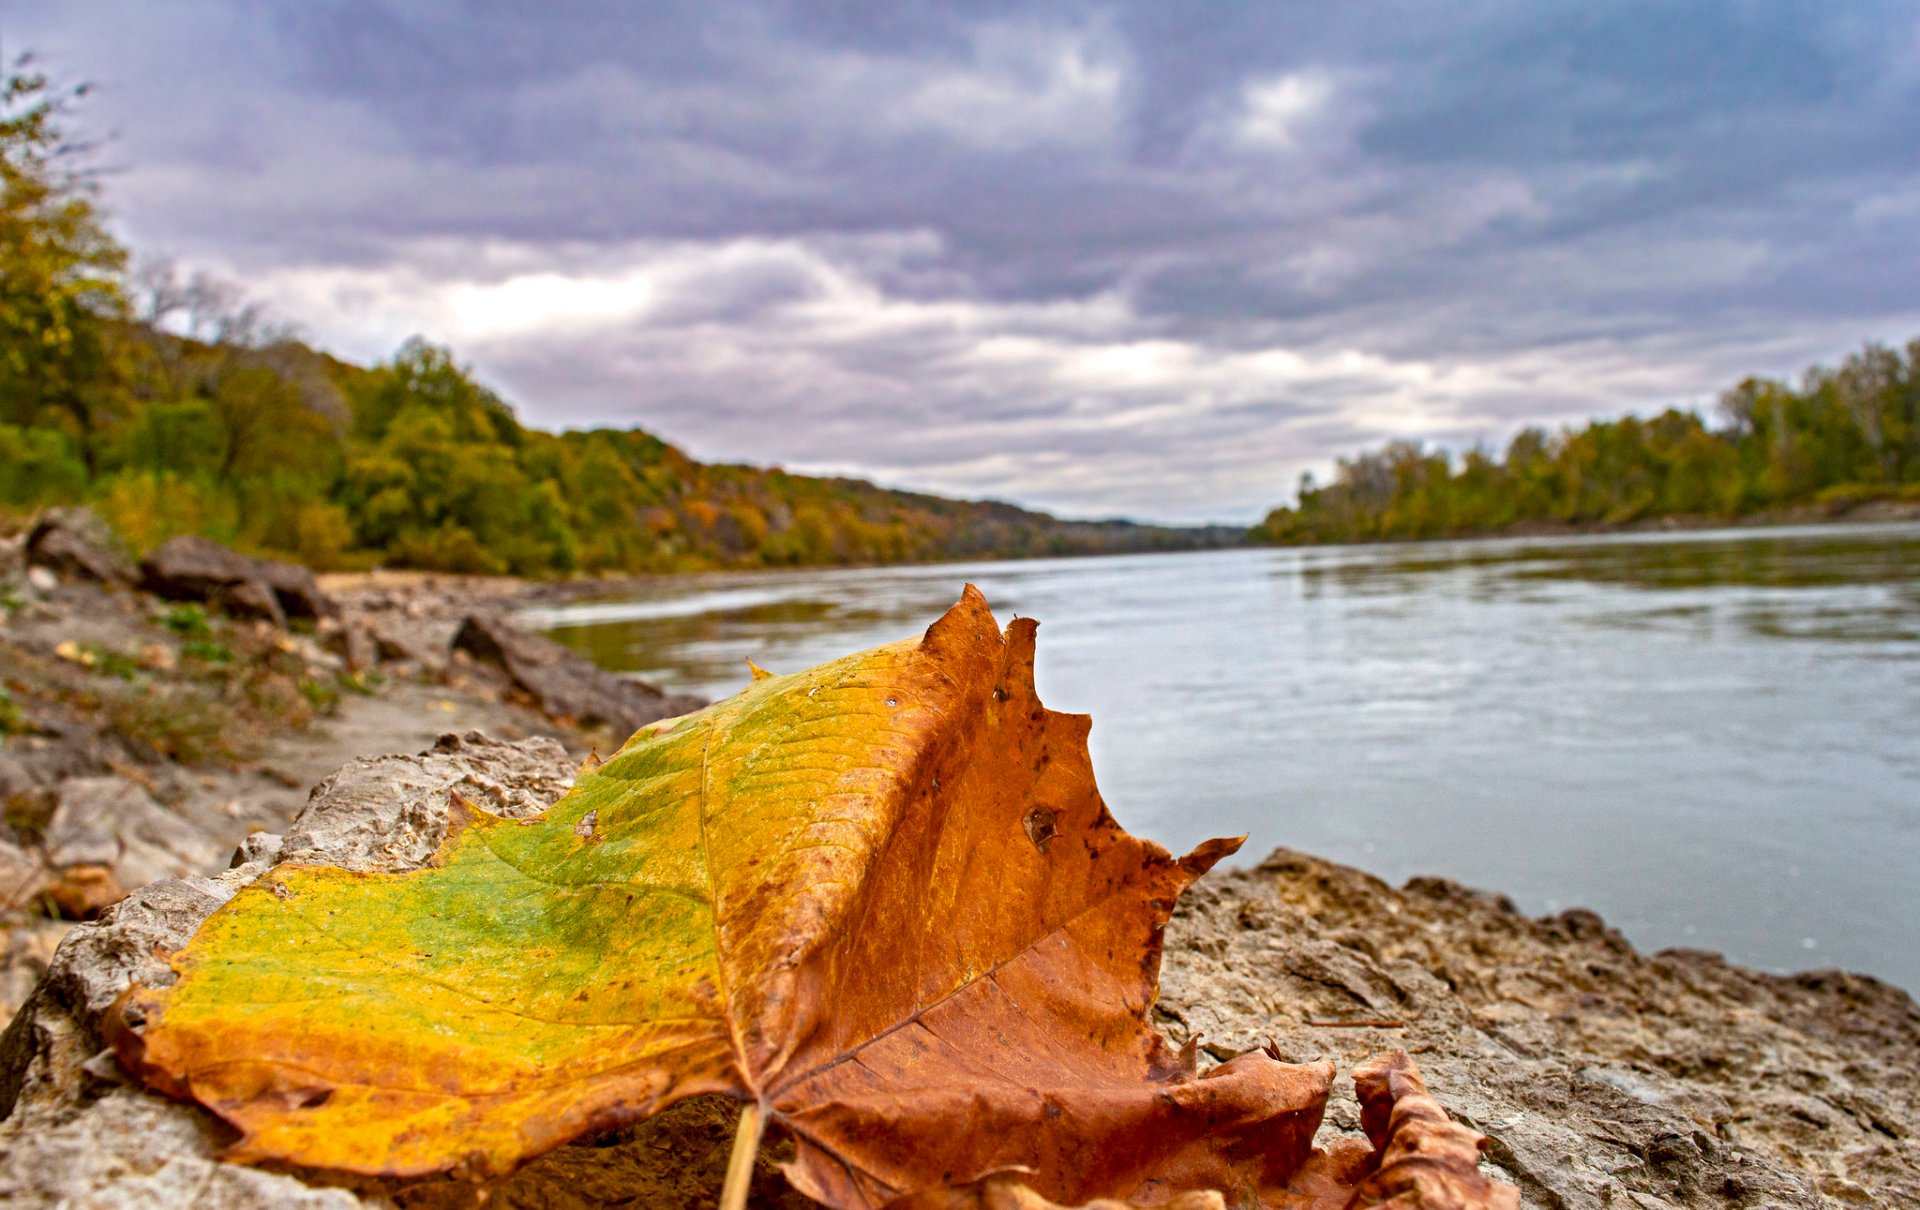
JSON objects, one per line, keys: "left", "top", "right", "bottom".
{"left": 46, "top": 776, "right": 227, "bottom": 914}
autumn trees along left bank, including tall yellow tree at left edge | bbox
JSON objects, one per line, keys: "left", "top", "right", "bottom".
{"left": 0, "top": 60, "right": 1213, "bottom": 576}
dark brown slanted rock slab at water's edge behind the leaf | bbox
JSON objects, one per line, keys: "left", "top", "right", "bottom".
{"left": 453, "top": 613, "right": 707, "bottom": 739}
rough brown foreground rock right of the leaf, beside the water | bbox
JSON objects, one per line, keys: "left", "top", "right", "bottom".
{"left": 1156, "top": 849, "right": 1920, "bottom": 1210}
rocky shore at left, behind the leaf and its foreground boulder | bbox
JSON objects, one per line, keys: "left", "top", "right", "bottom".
{"left": 0, "top": 511, "right": 703, "bottom": 1016}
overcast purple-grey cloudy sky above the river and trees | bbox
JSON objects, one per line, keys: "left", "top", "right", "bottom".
{"left": 11, "top": 0, "right": 1920, "bottom": 522}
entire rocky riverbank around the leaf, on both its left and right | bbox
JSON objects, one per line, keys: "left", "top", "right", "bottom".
{"left": 0, "top": 519, "right": 1920, "bottom": 1210}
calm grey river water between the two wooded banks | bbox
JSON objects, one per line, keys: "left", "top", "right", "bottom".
{"left": 528, "top": 524, "right": 1920, "bottom": 989}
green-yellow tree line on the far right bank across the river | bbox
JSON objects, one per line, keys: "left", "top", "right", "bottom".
{"left": 1252, "top": 340, "right": 1920, "bottom": 544}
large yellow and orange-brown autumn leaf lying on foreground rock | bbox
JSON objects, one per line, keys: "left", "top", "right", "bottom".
{"left": 111, "top": 588, "right": 1497, "bottom": 1206}
